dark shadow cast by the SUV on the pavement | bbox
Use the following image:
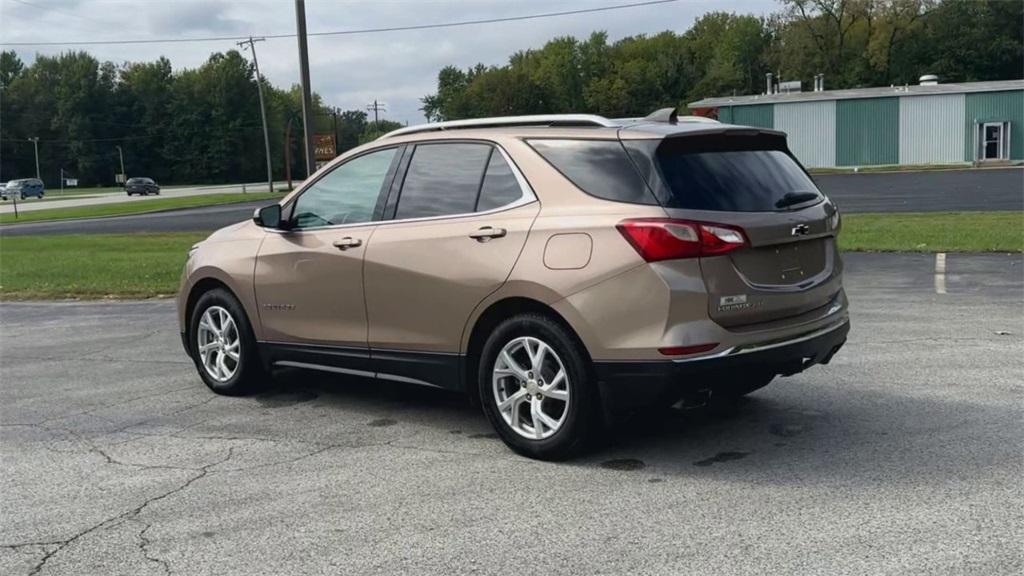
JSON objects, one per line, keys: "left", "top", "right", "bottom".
{"left": 256, "top": 370, "right": 1021, "bottom": 486}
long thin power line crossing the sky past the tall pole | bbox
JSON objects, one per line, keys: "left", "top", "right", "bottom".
{"left": 0, "top": 0, "right": 680, "bottom": 46}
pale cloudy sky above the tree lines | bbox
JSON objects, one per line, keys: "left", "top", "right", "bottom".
{"left": 0, "top": 0, "right": 778, "bottom": 123}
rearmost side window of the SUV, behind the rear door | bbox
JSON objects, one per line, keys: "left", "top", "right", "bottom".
{"left": 528, "top": 139, "right": 657, "bottom": 204}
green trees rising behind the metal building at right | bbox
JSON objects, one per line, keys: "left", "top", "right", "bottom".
{"left": 422, "top": 0, "right": 1024, "bottom": 120}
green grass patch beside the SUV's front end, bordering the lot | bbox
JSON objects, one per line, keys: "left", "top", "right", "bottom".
{"left": 0, "top": 233, "right": 207, "bottom": 299}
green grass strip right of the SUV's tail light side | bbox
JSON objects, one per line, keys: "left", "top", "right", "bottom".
{"left": 839, "top": 212, "right": 1024, "bottom": 252}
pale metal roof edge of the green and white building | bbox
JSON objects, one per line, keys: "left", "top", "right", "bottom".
{"left": 688, "top": 80, "right": 1024, "bottom": 109}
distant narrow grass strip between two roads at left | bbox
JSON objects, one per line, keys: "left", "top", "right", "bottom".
{"left": 0, "top": 192, "right": 282, "bottom": 223}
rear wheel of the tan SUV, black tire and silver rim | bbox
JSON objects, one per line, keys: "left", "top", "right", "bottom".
{"left": 477, "top": 314, "right": 599, "bottom": 460}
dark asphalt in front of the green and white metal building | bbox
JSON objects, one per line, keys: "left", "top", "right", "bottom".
{"left": 814, "top": 167, "right": 1024, "bottom": 212}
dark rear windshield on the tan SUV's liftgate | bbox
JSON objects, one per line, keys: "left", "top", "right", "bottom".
{"left": 627, "top": 138, "right": 821, "bottom": 212}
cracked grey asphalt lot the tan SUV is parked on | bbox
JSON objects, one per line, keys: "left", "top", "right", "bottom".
{"left": 0, "top": 254, "right": 1024, "bottom": 576}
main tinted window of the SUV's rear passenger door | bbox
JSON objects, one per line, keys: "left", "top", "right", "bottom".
{"left": 395, "top": 143, "right": 490, "bottom": 219}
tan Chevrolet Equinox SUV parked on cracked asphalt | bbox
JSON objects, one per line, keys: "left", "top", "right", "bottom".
{"left": 178, "top": 110, "right": 849, "bottom": 458}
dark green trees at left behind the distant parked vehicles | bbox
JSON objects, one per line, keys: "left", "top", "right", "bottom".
{"left": 0, "top": 50, "right": 399, "bottom": 188}
